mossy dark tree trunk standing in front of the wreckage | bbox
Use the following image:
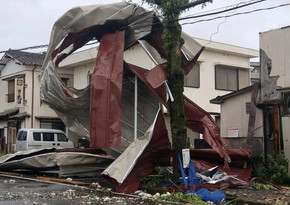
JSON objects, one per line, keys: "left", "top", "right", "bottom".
{"left": 144, "top": 0, "right": 211, "bottom": 181}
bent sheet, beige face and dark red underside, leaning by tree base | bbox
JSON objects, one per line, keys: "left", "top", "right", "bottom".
{"left": 103, "top": 109, "right": 172, "bottom": 193}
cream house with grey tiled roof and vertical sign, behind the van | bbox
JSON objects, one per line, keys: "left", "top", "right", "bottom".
{"left": 0, "top": 50, "right": 73, "bottom": 152}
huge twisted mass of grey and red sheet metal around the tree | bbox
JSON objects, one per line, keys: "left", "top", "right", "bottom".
{"left": 0, "top": 2, "right": 249, "bottom": 193}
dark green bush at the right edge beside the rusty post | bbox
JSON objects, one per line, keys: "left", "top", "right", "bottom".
{"left": 255, "top": 152, "right": 290, "bottom": 184}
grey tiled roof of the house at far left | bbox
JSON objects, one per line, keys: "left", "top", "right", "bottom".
{"left": 2, "top": 49, "right": 45, "bottom": 66}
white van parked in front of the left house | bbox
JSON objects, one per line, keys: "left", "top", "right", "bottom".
{"left": 15, "top": 128, "right": 74, "bottom": 151}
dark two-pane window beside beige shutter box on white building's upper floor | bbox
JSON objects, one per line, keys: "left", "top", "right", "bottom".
{"left": 215, "top": 65, "right": 238, "bottom": 91}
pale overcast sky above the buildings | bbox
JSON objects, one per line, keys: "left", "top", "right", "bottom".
{"left": 0, "top": 0, "right": 290, "bottom": 56}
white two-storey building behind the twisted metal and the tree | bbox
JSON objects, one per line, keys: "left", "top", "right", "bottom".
{"left": 60, "top": 34, "right": 258, "bottom": 144}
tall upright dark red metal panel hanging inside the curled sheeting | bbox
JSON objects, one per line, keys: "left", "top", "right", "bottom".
{"left": 90, "top": 31, "right": 125, "bottom": 148}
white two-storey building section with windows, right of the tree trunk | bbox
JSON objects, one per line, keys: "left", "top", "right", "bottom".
{"left": 184, "top": 38, "right": 259, "bottom": 115}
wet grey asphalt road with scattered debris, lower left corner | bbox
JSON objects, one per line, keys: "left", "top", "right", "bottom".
{"left": 0, "top": 176, "right": 175, "bottom": 205}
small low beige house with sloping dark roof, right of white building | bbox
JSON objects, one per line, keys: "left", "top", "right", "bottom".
{"left": 210, "top": 85, "right": 264, "bottom": 157}
